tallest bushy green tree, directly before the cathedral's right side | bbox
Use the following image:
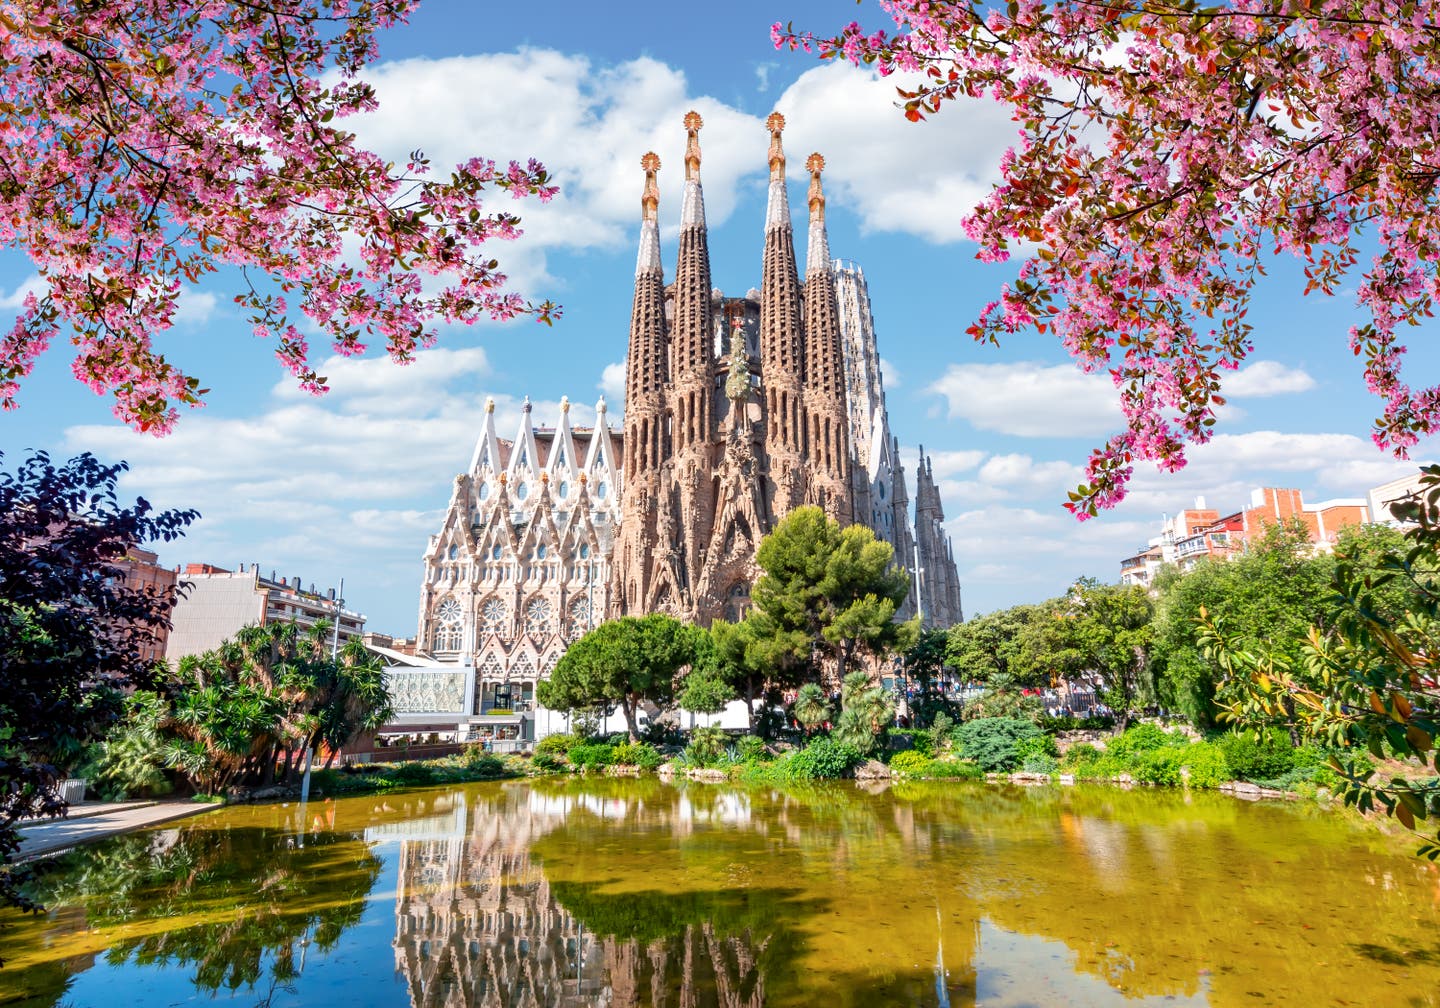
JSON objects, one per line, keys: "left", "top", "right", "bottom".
{"left": 746, "top": 507, "right": 919, "bottom": 684}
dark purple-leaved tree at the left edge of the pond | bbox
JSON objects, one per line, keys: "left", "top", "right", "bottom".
{"left": 0, "top": 452, "right": 197, "bottom": 907}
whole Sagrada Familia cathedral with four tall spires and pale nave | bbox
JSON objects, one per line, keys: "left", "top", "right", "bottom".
{"left": 418, "top": 112, "right": 962, "bottom": 713}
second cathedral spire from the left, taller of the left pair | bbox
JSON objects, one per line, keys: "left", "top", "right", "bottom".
{"left": 662, "top": 111, "right": 719, "bottom": 599}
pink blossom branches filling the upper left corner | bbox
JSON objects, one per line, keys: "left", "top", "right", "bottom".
{"left": 0, "top": 0, "right": 557, "bottom": 433}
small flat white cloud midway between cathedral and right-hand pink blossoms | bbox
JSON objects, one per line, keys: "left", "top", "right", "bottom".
{"left": 926, "top": 361, "right": 1123, "bottom": 438}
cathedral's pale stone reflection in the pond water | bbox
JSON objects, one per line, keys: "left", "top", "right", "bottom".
{"left": 366, "top": 788, "right": 785, "bottom": 1008}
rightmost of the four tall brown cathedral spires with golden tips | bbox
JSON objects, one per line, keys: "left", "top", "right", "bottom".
{"left": 801, "top": 154, "right": 854, "bottom": 524}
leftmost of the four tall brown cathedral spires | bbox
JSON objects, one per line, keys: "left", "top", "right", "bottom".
{"left": 611, "top": 151, "right": 670, "bottom": 615}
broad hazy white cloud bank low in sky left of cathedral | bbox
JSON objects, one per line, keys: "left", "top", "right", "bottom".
{"left": 56, "top": 347, "right": 616, "bottom": 634}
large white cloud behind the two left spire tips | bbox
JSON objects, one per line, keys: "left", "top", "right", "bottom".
{"left": 347, "top": 49, "right": 765, "bottom": 291}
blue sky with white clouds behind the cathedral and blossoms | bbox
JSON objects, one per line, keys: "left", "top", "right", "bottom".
{"left": 0, "top": 0, "right": 1440, "bottom": 635}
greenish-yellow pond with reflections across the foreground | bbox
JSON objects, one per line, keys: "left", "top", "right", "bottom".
{"left": 0, "top": 778, "right": 1440, "bottom": 1008}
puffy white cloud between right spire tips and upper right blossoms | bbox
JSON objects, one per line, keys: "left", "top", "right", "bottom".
{"left": 776, "top": 60, "right": 1017, "bottom": 242}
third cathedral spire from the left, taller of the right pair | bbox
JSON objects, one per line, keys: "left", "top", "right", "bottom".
{"left": 760, "top": 112, "right": 808, "bottom": 516}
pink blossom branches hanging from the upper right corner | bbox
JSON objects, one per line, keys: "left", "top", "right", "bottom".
{"left": 772, "top": 0, "right": 1440, "bottom": 518}
